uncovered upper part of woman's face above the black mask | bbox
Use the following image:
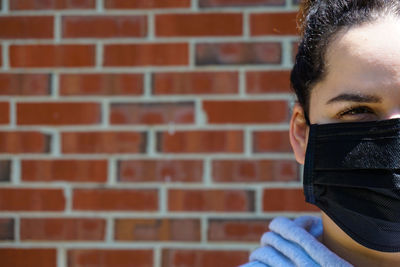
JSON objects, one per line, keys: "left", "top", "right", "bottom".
{"left": 310, "top": 17, "right": 400, "bottom": 124}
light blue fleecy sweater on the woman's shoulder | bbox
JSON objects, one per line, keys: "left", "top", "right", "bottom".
{"left": 241, "top": 216, "right": 352, "bottom": 267}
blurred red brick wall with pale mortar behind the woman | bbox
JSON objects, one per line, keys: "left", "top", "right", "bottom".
{"left": 0, "top": 0, "right": 316, "bottom": 267}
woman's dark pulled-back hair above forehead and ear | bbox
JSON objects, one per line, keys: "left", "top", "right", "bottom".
{"left": 290, "top": 0, "right": 400, "bottom": 120}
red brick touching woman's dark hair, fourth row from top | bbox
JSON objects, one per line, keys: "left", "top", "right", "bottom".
{"left": 246, "top": 71, "right": 291, "bottom": 94}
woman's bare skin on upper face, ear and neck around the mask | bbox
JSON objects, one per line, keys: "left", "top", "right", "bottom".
{"left": 290, "top": 16, "right": 400, "bottom": 266}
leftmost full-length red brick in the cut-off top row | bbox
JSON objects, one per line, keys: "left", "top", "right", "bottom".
{"left": 9, "top": 0, "right": 96, "bottom": 10}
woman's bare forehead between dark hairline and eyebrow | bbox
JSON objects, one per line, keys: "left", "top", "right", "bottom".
{"left": 311, "top": 16, "right": 400, "bottom": 106}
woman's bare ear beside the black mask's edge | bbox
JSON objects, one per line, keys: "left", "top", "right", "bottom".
{"left": 289, "top": 103, "right": 309, "bottom": 164}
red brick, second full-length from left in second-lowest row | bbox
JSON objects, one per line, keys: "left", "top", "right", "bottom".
{"left": 115, "top": 218, "right": 200, "bottom": 242}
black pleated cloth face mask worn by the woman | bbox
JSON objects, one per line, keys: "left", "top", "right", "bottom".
{"left": 304, "top": 119, "right": 400, "bottom": 252}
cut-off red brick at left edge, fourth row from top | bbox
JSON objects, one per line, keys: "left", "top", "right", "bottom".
{"left": 0, "top": 73, "right": 50, "bottom": 96}
